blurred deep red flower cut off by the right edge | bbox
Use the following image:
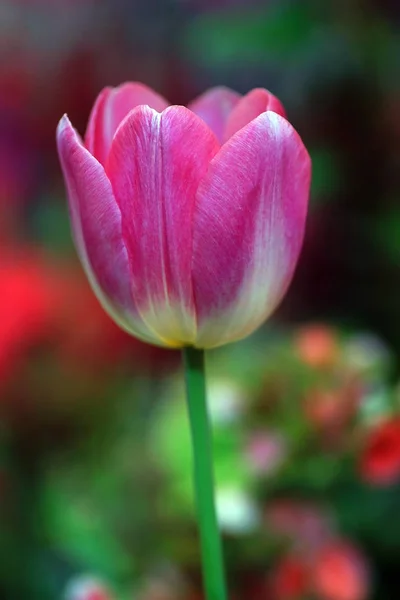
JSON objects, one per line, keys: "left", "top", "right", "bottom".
{"left": 360, "top": 416, "right": 400, "bottom": 485}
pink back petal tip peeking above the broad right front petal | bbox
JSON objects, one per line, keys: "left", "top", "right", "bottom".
{"left": 223, "top": 88, "right": 286, "bottom": 142}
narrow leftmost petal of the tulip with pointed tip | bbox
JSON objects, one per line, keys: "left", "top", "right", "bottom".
{"left": 57, "top": 116, "right": 163, "bottom": 345}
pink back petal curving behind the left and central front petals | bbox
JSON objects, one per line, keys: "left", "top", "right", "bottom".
{"left": 85, "top": 83, "right": 169, "bottom": 165}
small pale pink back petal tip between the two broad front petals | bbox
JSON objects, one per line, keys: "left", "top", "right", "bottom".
{"left": 188, "top": 86, "right": 241, "bottom": 143}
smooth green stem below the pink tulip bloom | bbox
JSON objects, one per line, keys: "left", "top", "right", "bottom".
{"left": 183, "top": 348, "right": 227, "bottom": 600}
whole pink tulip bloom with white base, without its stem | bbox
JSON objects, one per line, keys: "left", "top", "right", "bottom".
{"left": 57, "top": 83, "right": 311, "bottom": 348}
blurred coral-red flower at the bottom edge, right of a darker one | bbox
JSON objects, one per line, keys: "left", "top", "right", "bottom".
{"left": 312, "top": 541, "right": 369, "bottom": 600}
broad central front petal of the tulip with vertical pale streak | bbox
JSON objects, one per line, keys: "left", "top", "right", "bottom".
{"left": 107, "top": 106, "right": 219, "bottom": 346}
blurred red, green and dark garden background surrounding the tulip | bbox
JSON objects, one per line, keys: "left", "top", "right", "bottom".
{"left": 0, "top": 0, "right": 400, "bottom": 600}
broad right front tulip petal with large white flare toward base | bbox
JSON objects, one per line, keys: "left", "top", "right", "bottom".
{"left": 193, "top": 111, "right": 311, "bottom": 348}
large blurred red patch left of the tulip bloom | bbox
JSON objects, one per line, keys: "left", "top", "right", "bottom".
{"left": 0, "top": 248, "right": 170, "bottom": 394}
